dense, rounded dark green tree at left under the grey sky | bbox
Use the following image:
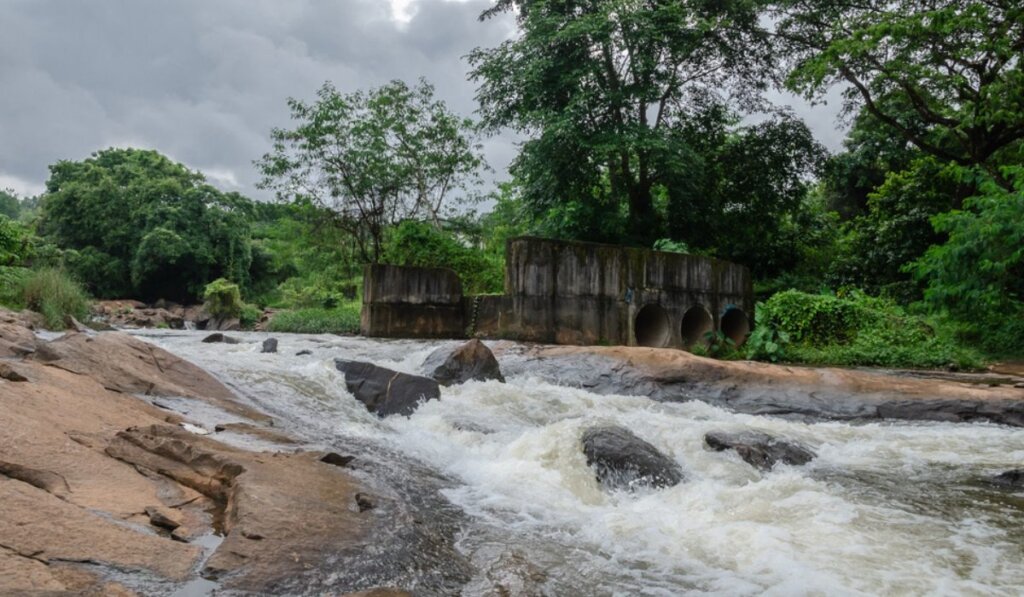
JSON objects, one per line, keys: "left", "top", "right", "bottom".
{"left": 39, "top": 150, "right": 251, "bottom": 301}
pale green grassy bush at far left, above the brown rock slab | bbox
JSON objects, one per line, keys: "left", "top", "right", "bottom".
{"left": 12, "top": 267, "right": 89, "bottom": 330}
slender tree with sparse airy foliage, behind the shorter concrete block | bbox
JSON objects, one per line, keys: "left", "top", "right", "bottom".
{"left": 256, "top": 80, "right": 484, "bottom": 262}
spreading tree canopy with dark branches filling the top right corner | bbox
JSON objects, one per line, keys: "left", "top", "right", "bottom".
{"left": 776, "top": 0, "right": 1024, "bottom": 173}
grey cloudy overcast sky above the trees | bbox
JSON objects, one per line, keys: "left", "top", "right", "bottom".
{"left": 0, "top": 0, "right": 843, "bottom": 198}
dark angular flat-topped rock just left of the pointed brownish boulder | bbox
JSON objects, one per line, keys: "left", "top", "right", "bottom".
{"left": 334, "top": 358, "right": 441, "bottom": 418}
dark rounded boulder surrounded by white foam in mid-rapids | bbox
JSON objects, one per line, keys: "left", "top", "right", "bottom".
{"left": 583, "top": 427, "right": 683, "bottom": 489}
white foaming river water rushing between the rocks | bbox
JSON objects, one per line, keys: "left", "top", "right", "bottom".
{"left": 141, "top": 332, "right": 1024, "bottom": 595}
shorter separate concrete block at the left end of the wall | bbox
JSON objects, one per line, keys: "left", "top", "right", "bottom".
{"left": 360, "top": 265, "right": 465, "bottom": 338}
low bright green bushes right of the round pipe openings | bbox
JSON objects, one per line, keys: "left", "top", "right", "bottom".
{"left": 750, "top": 290, "right": 984, "bottom": 370}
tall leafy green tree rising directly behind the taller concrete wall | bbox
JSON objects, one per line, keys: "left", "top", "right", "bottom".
{"left": 469, "top": 0, "right": 768, "bottom": 246}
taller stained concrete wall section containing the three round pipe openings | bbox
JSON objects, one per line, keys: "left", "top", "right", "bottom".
{"left": 476, "top": 238, "right": 754, "bottom": 347}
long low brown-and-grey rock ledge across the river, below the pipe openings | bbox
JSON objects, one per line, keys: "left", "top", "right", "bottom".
{"left": 495, "top": 345, "right": 1024, "bottom": 427}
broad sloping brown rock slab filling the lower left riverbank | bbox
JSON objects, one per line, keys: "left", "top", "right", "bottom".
{"left": 0, "top": 311, "right": 458, "bottom": 595}
